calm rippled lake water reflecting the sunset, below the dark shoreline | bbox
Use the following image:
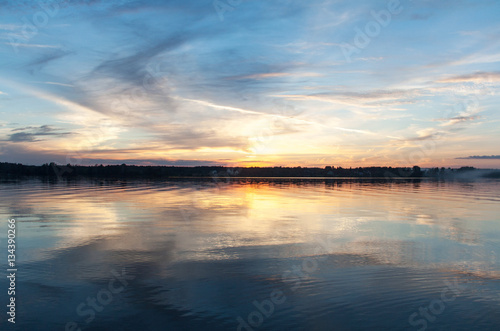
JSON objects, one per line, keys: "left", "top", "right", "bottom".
{"left": 0, "top": 180, "right": 500, "bottom": 331}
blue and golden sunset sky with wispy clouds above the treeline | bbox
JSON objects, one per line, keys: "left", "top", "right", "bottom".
{"left": 0, "top": 0, "right": 500, "bottom": 168}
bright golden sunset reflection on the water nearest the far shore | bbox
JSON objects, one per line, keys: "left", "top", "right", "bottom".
{"left": 6, "top": 180, "right": 497, "bottom": 274}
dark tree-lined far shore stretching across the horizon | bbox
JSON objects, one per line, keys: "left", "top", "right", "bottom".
{"left": 0, "top": 162, "right": 500, "bottom": 181}
